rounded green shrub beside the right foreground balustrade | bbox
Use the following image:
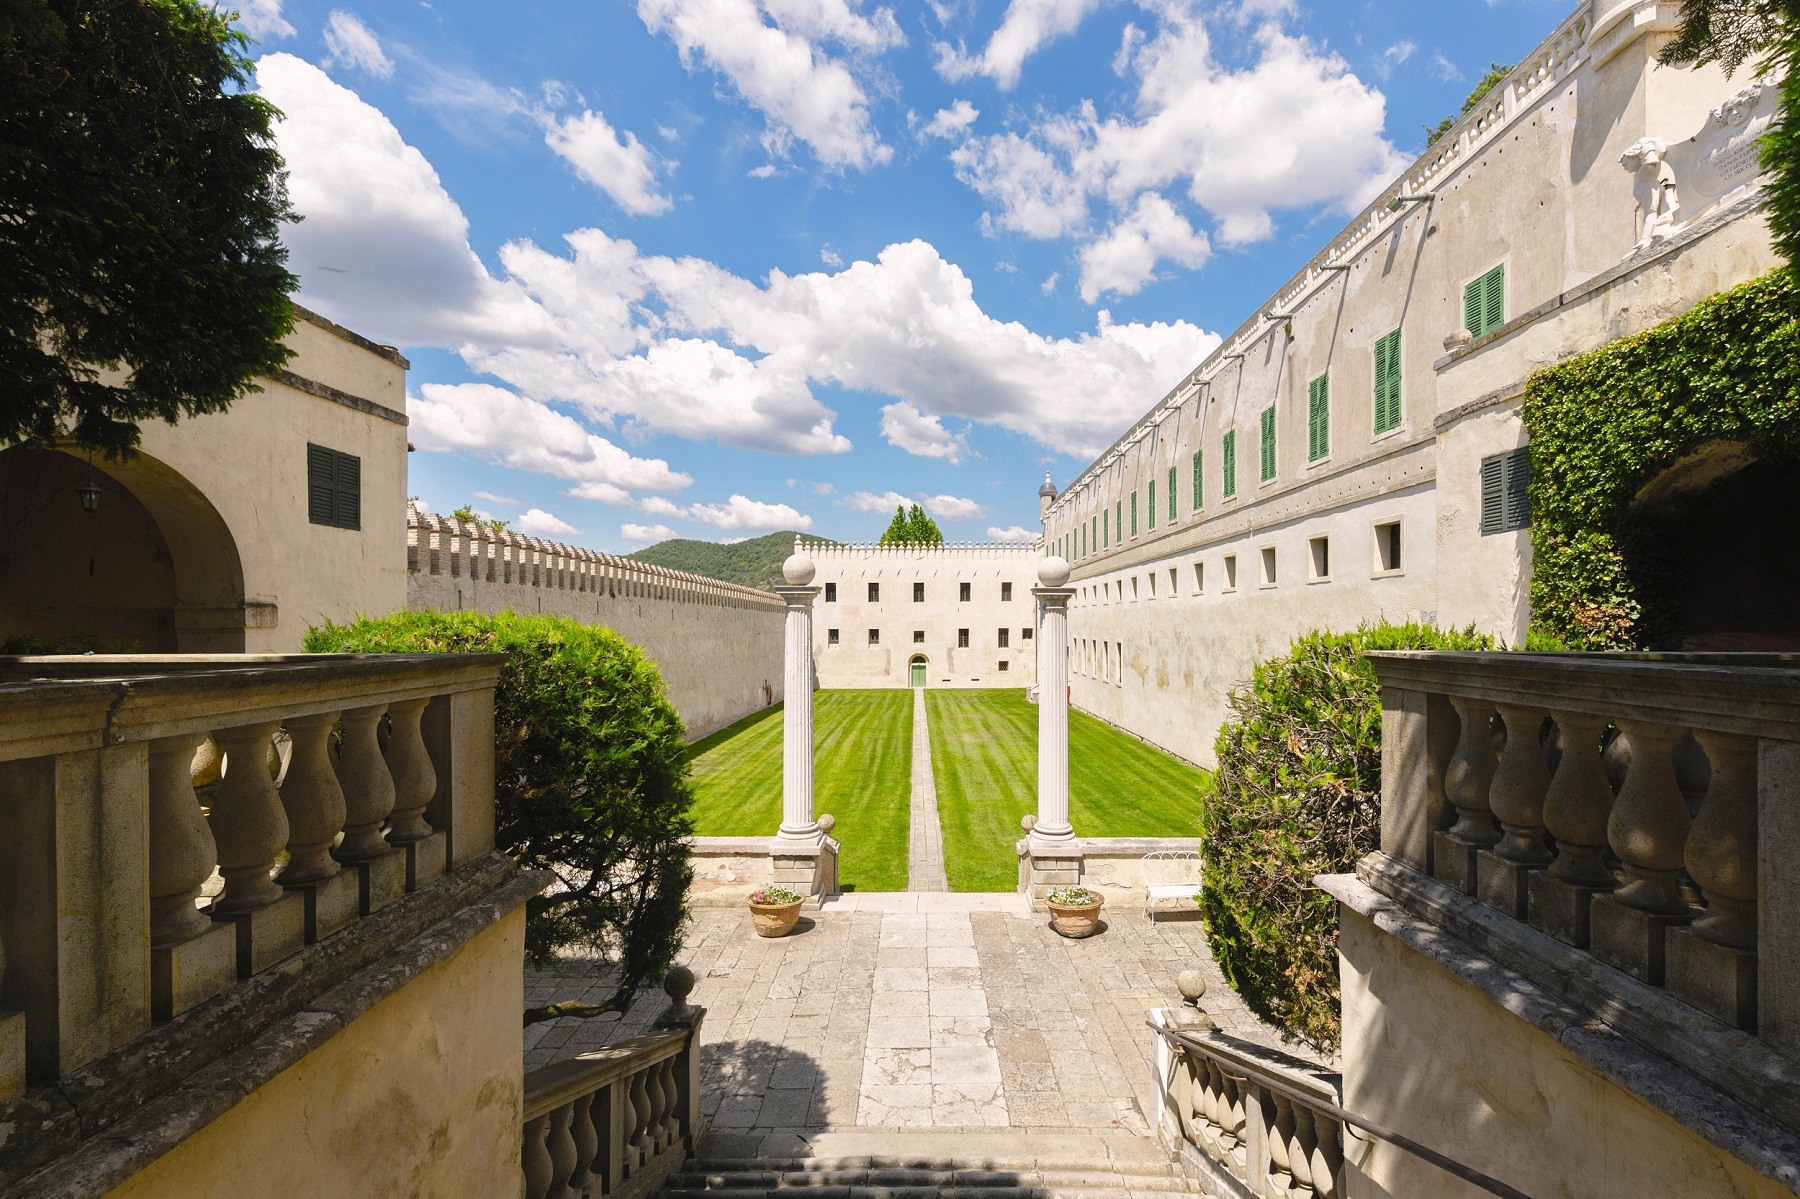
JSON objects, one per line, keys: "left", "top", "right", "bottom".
{"left": 1199, "top": 625, "right": 1492, "bottom": 1051}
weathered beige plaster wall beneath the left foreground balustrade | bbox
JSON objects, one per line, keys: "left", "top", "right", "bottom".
{"left": 110, "top": 907, "right": 526, "bottom": 1199}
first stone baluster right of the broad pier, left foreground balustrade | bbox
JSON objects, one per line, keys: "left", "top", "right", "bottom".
{"left": 149, "top": 733, "right": 218, "bottom": 945}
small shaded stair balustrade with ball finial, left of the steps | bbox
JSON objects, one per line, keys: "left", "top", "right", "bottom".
{"left": 520, "top": 967, "right": 706, "bottom": 1199}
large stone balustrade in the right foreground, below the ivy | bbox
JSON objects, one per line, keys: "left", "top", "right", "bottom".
{"left": 1366, "top": 652, "right": 1800, "bottom": 1053}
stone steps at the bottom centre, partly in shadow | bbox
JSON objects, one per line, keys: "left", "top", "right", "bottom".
{"left": 664, "top": 1131, "right": 1201, "bottom": 1199}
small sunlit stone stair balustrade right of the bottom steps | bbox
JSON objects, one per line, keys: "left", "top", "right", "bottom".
{"left": 1150, "top": 1008, "right": 1345, "bottom": 1199}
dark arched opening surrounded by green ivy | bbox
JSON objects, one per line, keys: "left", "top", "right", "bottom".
{"left": 1627, "top": 441, "right": 1800, "bottom": 652}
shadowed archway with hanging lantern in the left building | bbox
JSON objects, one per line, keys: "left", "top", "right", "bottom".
{"left": 0, "top": 446, "right": 247, "bottom": 654}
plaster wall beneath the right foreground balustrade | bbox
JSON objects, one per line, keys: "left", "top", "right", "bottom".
{"left": 1337, "top": 904, "right": 1791, "bottom": 1199}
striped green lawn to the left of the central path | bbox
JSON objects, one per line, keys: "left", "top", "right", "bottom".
{"left": 689, "top": 690, "right": 913, "bottom": 891}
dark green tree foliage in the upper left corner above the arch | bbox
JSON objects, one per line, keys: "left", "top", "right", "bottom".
{"left": 0, "top": 0, "right": 295, "bottom": 457}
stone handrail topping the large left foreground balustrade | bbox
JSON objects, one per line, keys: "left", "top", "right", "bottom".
{"left": 0, "top": 654, "right": 506, "bottom": 762}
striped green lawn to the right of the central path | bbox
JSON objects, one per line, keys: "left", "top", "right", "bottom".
{"left": 925, "top": 690, "right": 1204, "bottom": 891}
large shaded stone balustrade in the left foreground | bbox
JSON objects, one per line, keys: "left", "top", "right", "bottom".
{"left": 0, "top": 655, "right": 502, "bottom": 1100}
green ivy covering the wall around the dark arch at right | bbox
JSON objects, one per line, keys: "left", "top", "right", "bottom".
{"left": 1523, "top": 266, "right": 1800, "bottom": 650}
